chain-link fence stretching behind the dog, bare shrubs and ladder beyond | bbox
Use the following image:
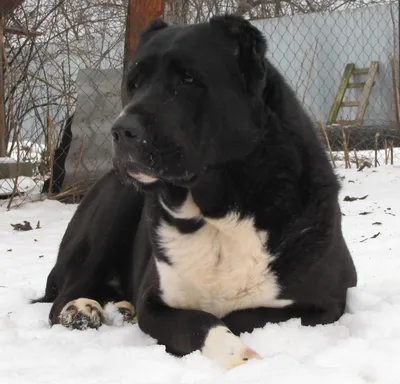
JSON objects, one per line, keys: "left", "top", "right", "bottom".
{"left": 0, "top": 0, "right": 400, "bottom": 207}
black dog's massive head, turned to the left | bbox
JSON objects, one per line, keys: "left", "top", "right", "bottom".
{"left": 112, "top": 16, "right": 266, "bottom": 186}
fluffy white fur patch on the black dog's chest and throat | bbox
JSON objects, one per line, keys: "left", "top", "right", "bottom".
{"left": 156, "top": 194, "right": 291, "bottom": 318}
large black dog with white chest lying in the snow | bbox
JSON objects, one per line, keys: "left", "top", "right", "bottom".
{"left": 32, "top": 16, "right": 357, "bottom": 368}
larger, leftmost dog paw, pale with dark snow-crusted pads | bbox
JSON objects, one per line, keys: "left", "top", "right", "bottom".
{"left": 60, "top": 298, "right": 104, "bottom": 330}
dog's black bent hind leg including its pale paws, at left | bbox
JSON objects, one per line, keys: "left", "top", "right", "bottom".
{"left": 38, "top": 172, "right": 144, "bottom": 329}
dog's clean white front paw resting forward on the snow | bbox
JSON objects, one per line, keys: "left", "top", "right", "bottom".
{"left": 202, "top": 326, "right": 262, "bottom": 369}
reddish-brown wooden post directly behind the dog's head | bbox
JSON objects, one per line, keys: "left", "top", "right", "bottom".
{"left": 122, "top": 0, "right": 165, "bottom": 106}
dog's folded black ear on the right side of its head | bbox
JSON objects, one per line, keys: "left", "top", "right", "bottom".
{"left": 210, "top": 15, "right": 267, "bottom": 91}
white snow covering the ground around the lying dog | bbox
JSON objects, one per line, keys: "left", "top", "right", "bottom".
{"left": 0, "top": 165, "right": 400, "bottom": 384}
